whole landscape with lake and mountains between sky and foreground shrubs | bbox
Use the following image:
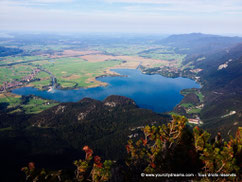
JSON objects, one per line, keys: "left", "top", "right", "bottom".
{"left": 0, "top": 34, "right": 242, "bottom": 182}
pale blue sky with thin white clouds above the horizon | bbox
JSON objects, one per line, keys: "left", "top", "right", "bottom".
{"left": 0, "top": 0, "right": 242, "bottom": 35}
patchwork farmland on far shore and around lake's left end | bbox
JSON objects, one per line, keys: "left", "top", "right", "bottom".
{"left": 0, "top": 44, "right": 189, "bottom": 114}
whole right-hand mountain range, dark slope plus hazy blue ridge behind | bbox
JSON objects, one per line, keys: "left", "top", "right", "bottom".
{"left": 163, "top": 34, "right": 242, "bottom": 134}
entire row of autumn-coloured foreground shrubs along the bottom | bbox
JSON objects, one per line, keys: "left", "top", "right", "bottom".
{"left": 22, "top": 116, "right": 242, "bottom": 182}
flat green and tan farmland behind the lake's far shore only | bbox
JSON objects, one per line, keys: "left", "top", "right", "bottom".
{"left": 0, "top": 45, "right": 184, "bottom": 89}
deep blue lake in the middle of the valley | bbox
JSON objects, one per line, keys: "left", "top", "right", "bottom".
{"left": 12, "top": 69, "right": 200, "bottom": 112}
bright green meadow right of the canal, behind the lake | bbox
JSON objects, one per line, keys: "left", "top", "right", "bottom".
{"left": 34, "top": 58, "right": 121, "bottom": 88}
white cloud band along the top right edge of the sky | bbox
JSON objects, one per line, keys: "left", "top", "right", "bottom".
{"left": 102, "top": 0, "right": 242, "bottom": 13}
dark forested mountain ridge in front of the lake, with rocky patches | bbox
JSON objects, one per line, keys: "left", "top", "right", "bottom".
{"left": 0, "top": 96, "right": 170, "bottom": 179}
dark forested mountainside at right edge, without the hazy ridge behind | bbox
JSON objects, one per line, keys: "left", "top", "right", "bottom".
{"left": 194, "top": 44, "right": 242, "bottom": 132}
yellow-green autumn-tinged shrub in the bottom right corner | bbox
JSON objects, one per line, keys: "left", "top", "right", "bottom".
{"left": 193, "top": 127, "right": 242, "bottom": 181}
